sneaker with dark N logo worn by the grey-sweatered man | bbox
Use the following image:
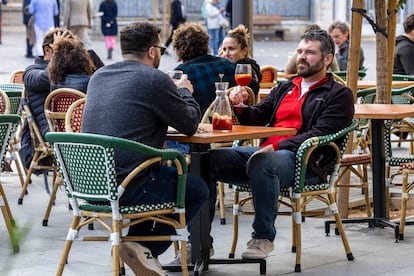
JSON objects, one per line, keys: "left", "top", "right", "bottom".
{"left": 119, "top": 242, "right": 166, "bottom": 276}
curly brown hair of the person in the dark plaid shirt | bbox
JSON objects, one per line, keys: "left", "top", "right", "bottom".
{"left": 173, "top": 23, "right": 210, "bottom": 61}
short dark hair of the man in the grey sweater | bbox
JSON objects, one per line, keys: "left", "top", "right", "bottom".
{"left": 120, "top": 22, "right": 161, "bottom": 57}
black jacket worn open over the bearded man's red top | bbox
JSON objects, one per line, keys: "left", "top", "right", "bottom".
{"left": 236, "top": 74, "right": 354, "bottom": 180}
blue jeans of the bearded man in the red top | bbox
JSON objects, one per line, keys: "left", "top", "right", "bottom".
{"left": 210, "top": 147, "right": 321, "bottom": 241}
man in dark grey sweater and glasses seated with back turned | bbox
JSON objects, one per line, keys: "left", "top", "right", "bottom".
{"left": 82, "top": 23, "right": 208, "bottom": 275}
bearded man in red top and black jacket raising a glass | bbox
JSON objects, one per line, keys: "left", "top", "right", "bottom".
{"left": 209, "top": 30, "right": 354, "bottom": 259}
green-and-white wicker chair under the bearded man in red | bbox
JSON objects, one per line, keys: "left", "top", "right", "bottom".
{"left": 229, "top": 121, "right": 358, "bottom": 272}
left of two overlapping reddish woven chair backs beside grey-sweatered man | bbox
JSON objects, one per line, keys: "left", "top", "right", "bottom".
{"left": 45, "top": 88, "right": 86, "bottom": 132}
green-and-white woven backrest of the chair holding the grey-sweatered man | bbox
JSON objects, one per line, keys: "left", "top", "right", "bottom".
{"left": 46, "top": 132, "right": 187, "bottom": 207}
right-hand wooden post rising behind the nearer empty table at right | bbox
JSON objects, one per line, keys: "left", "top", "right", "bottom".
{"left": 375, "top": 0, "right": 394, "bottom": 104}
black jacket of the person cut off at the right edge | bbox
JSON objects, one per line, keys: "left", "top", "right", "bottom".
{"left": 393, "top": 35, "right": 414, "bottom": 75}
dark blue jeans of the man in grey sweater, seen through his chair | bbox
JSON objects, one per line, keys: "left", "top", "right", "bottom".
{"left": 124, "top": 166, "right": 209, "bottom": 257}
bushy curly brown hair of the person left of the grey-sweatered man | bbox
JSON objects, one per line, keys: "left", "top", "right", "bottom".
{"left": 48, "top": 37, "right": 96, "bottom": 84}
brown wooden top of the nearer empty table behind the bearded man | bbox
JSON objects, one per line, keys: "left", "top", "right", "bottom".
{"left": 354, "top": 104, "right": 414, "bottom": 120}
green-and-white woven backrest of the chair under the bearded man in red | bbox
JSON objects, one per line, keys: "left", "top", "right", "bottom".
{"left": 294, "top": 120, "right": 359, "bottom": 193}
